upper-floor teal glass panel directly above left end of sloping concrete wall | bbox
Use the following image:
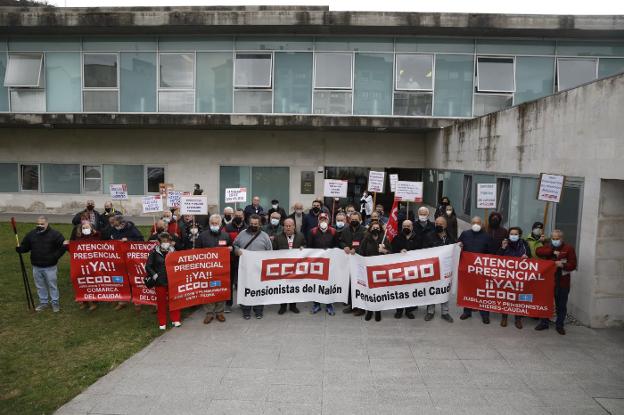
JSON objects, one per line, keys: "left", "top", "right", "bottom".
{"left": 433, "top": 55, "right": 474, "bottom": 117}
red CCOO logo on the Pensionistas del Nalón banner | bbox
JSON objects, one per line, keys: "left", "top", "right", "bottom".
{"left": 260, "top": 258, "right": 329, "bottom": 281}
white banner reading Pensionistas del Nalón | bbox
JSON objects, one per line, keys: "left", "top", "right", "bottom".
{"left": 237, "top": 248, "right": 349, "bottom": 305}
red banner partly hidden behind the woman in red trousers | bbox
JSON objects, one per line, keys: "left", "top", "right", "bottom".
{"left": 126, "top": 241, "right": 158, "bottom": 306}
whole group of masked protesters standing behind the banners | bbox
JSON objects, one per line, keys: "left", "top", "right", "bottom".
{"left": 16, "top": 192, "right": 576, "bottom": 334}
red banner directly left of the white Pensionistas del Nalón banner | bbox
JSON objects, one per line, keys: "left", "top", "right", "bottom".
{"left": 165, "top": 248, "right": 231, "bottom": 310}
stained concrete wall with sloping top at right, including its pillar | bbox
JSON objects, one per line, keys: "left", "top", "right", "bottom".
{"left": 426, "top": 75, "right": 624, "bottom": 327}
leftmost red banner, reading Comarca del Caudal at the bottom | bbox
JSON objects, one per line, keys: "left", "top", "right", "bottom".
{"left": 69, "top": 241, "right": 130, "bottom": 302}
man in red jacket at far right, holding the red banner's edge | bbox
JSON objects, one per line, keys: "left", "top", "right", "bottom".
{"left": 535, "top": 229, "right": 576, "bottom": 335}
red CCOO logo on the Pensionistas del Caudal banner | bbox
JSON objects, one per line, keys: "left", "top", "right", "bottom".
{"left": 366, "top": 257, "right": 440, "bottom": 288}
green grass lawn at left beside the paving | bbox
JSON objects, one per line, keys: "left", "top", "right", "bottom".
{"left": 0, "top": 223, "right": 160, "bottom": 414}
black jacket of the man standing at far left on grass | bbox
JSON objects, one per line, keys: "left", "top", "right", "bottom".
{"left": 17, "top": 225, "right": 66, "bottom": 267}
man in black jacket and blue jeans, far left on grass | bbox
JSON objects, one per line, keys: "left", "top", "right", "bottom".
{"left": 15, "top": 216, "right": 66, "bottom": 313}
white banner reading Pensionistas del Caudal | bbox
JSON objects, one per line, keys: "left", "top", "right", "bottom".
{"left": 349, "top": 244, "right": 461, "bottom": 311}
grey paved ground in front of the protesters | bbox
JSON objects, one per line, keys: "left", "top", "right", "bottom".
{"left": 58, "top": 304, "right": 624, "bottom": 415}
